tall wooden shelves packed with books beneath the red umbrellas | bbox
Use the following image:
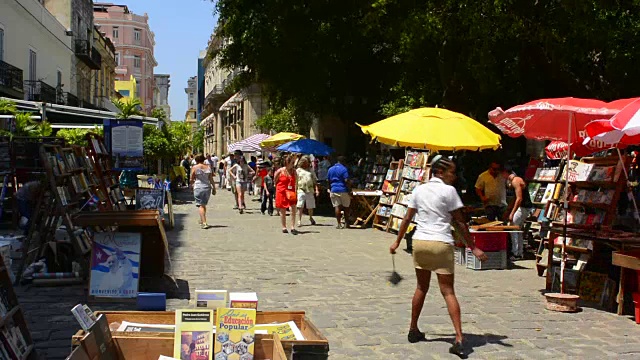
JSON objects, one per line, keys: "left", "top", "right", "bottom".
{"left": 529, "top": 156, "right": 640, "bottom": 314}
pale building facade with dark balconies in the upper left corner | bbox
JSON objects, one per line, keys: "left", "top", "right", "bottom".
{"left": 0, "top": 0, "right": 75, "bottom": 104}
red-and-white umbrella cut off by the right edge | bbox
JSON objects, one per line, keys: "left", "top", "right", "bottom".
{"left": 586, "top": 99, "right": 640, "bottom": 145}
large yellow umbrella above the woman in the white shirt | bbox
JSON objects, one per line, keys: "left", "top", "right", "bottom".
{"left": 357, "top": 108, "right": 500, "bottom": 151}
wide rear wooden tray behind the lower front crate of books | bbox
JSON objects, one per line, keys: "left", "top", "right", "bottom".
{"left": 72, "top": 311, "right": 329, "bottom": 360}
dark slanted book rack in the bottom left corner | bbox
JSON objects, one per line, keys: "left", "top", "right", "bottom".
{"left": 0, "top": 256, "right": 37, "bottom": 359}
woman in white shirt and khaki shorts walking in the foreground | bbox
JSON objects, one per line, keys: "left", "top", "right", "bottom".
{"left": 389, "top": 155, "right": 487, "bottom": 358}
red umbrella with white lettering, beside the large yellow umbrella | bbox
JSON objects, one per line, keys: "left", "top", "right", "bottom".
{"left": 489, "top": 97, "right": 636, "bottom": 145}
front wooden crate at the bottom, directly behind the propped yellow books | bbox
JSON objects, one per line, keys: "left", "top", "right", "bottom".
{"left": 70, "top": 333, "right": 287, "bottom": 360}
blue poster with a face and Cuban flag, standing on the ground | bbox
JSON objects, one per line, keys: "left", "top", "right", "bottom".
{"left": 89, "top": 232, "right": 141, "bottom": 298}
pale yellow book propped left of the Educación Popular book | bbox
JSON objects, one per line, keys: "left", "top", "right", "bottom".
{"left": 173, "top": 309, "right": 213, "bottom": 360}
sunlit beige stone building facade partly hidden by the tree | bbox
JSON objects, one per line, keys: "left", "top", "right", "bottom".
{"left": 200, "top": 33, "right": 268, "bottom": 155}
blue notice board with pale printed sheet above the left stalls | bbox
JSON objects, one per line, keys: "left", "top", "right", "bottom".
{"left": 109, "top": 120, "right": 144, "bottom": 171}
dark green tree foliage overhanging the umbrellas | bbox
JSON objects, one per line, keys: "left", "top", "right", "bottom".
{"left": 214, "top": 0, "right": 640, "bottom": 122}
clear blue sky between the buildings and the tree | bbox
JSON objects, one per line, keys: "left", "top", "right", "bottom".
{"left": 117, "top": 0, "right": 216, "bottom": 120}
